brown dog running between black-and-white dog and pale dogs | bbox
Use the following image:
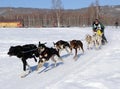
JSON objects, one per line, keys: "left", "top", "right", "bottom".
{"left": 70, "top": 40, "right": 84, "bottom": 58}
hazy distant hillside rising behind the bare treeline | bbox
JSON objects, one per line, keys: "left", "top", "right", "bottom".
{"left": 0, "top": 5, "right": 120, "bottom": 16}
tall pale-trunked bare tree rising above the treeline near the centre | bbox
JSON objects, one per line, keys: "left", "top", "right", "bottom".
{"left": 52, "top": 0, "right": 63, "bottom": 27}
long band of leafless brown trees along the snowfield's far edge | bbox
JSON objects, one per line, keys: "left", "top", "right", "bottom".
{"left": 0, "top": 5, "right": 117, "bottom": 27}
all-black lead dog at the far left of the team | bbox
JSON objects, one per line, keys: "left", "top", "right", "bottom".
{"left": 8, "top": 44, "right": 39, "bottom": 77}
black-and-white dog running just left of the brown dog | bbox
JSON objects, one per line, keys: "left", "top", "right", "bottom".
{"left": 53, "top": 40, "right": 70, "bottom": 53}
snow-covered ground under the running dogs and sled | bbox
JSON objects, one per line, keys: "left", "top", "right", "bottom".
{"left": 0, "top": 27, "right": 120, "bottom": 89}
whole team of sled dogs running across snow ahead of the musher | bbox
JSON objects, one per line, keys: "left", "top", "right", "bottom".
{"left": 8, "top": 33, "right": 107, "bottom": 77}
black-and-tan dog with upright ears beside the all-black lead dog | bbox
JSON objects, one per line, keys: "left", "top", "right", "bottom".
{"left": 37, "top": 42, "right": 63, "bottom": 70}
